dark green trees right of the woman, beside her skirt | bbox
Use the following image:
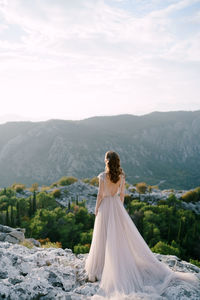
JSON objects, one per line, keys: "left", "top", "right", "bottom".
{"left": 124, "top": 193, "right": 200, "bottom": 260}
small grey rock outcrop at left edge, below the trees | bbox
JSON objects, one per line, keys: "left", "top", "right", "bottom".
{"left": 0, "top": 224, "right": 25, "bottom": 244}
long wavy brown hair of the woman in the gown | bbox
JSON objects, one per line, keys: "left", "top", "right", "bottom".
{"left": 105, "top": 151, "right": 125, "bottom": 183}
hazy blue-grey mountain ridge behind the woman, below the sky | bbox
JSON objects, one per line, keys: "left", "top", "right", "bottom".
{"left": 0, "top": 111, "right": 200, "bottom": 189}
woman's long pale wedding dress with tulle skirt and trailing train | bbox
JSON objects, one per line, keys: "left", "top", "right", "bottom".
{"left": 85, "top": 172, "right": 198, "bottom": 299}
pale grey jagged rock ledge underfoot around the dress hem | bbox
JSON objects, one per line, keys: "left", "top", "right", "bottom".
{"left": 0, "top": 242, "right": 200, "bottom": 300}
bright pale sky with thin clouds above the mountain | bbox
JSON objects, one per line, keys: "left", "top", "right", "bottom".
{"left": 0, "top": 0, "right": 200, "bottom": 123}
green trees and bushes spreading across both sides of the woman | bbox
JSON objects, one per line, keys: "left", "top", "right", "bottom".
{"left": 0, "top": 180, "right": 200, "bottom": 266}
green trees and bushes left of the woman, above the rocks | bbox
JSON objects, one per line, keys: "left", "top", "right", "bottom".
{"left": 0, "top": 188, "right": 95, "bottom": 253}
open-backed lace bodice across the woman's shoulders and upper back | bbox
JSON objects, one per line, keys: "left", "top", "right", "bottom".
{"left": 98, "top": 171, "right": 125, "bottom": 198}
